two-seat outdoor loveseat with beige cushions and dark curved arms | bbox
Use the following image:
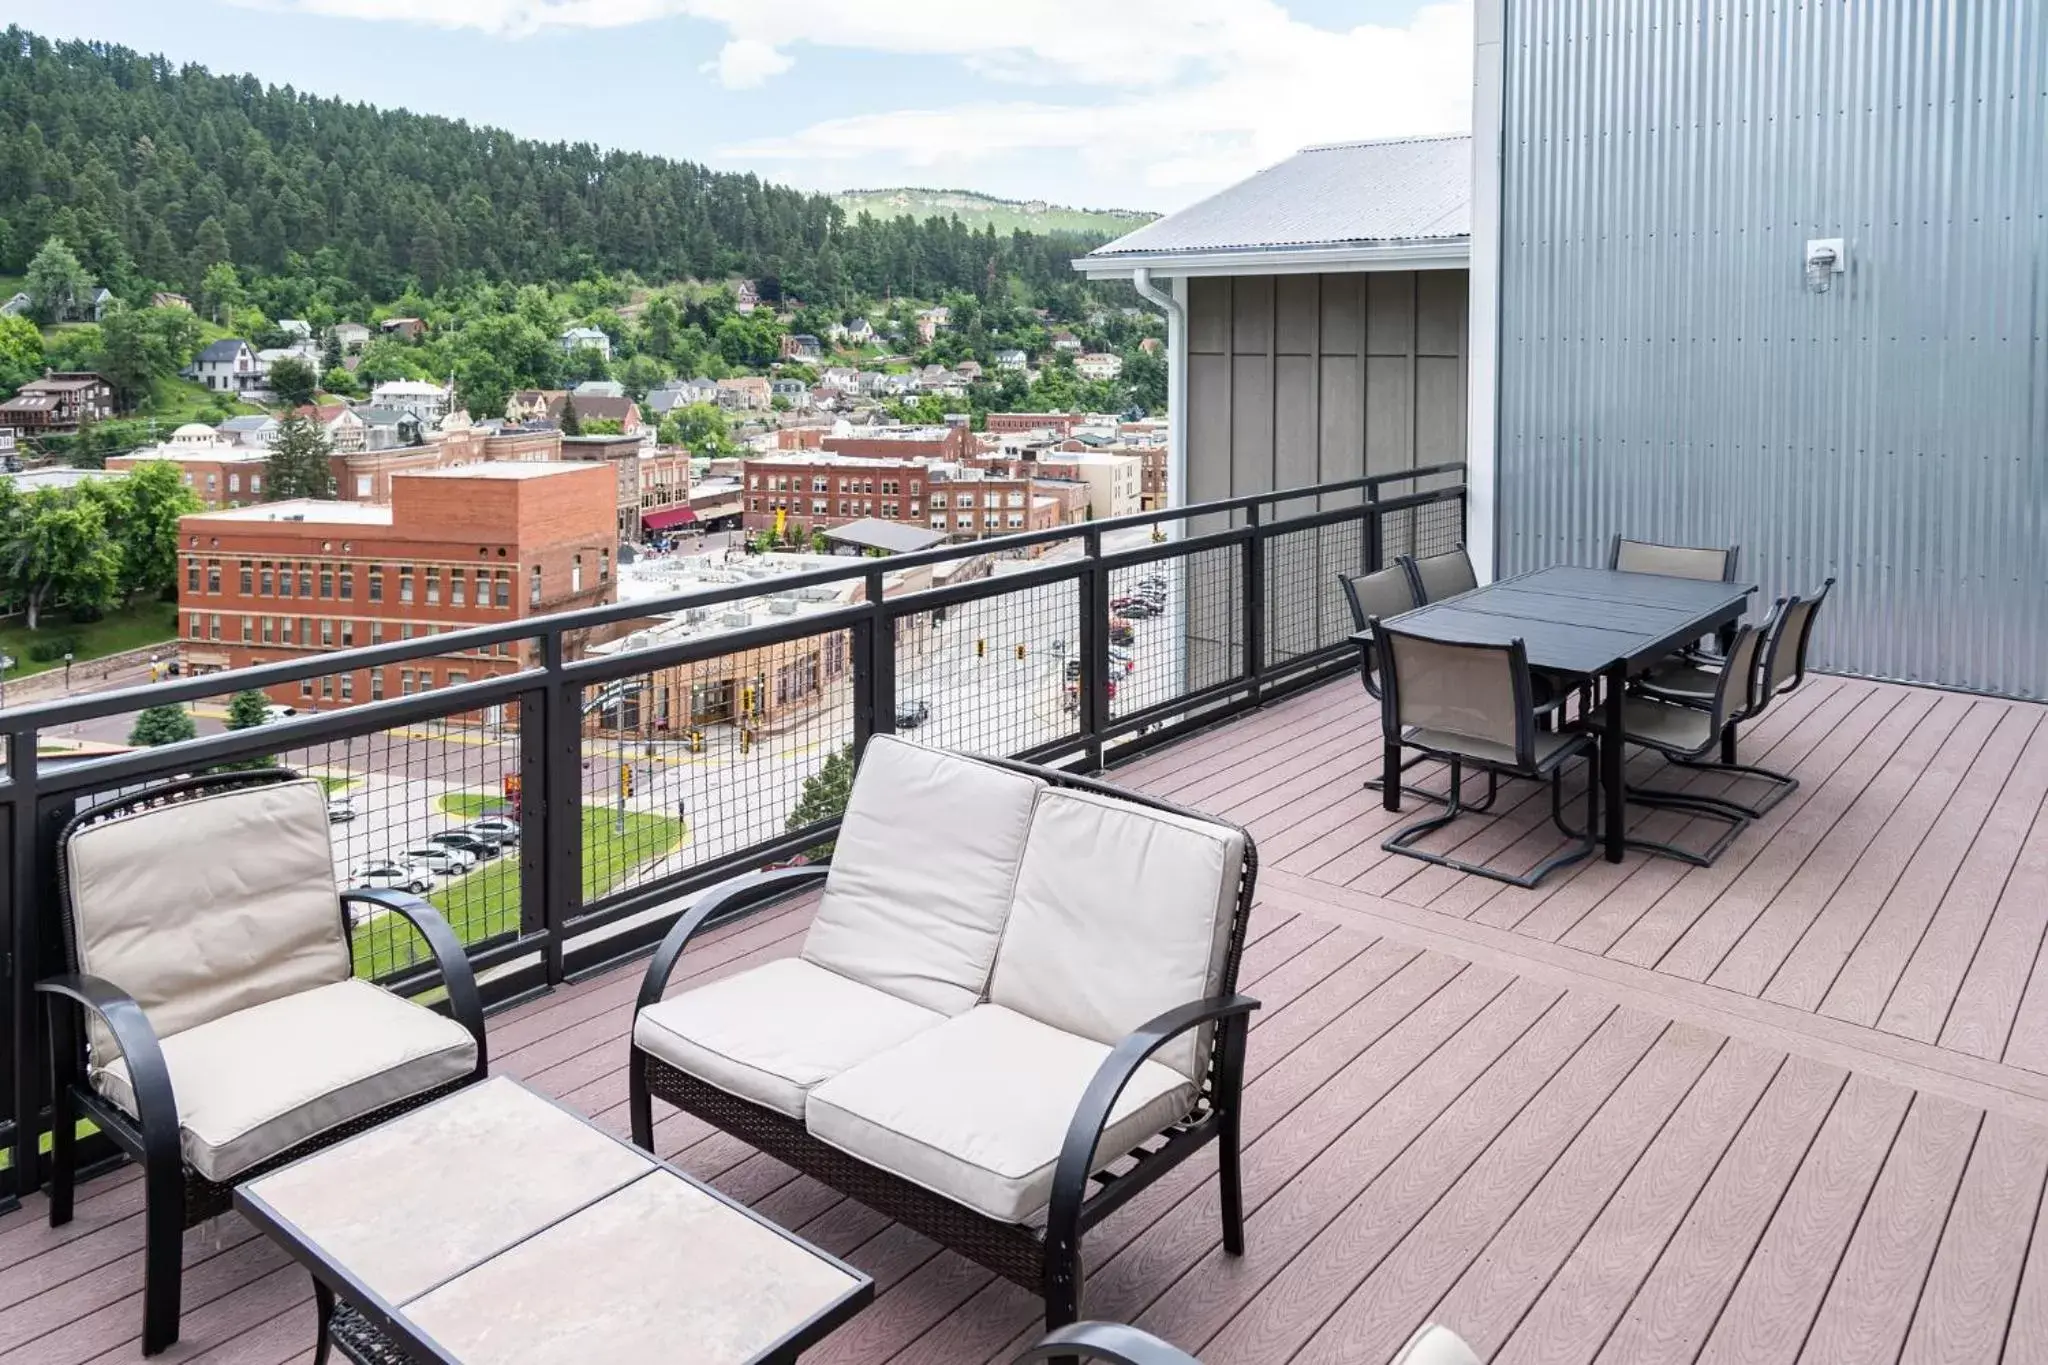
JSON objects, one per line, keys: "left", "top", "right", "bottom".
{"left": 629, "top": 737, "right": 1257, "bottom": 1328}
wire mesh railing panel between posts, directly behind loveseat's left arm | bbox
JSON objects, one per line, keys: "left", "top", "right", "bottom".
{"left": 580, "top": 630, "right": 854, "bottom": 911}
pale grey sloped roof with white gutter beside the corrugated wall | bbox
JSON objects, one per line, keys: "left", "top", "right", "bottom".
{"left": 1073, "top": 135, "right": 1473, "bottom": 276}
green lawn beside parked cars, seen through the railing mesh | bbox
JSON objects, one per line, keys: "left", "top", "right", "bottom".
{"left": 354, "top": 806, "right": 684, "bottom": 976}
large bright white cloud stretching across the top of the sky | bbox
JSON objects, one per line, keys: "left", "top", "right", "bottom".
{"left": 248, "top": 0, "right": 1473, "bottom": 209}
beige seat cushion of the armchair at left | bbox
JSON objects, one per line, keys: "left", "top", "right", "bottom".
{"left": 92, "top": 980, "right": 477, "bottom": 1181}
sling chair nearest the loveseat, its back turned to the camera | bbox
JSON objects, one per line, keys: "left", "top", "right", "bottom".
{"left": 1372, "top": 622, "right": 1599, "bottom": 886}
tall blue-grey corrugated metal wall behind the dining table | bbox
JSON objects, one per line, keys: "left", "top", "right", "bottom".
{"left": 1499, "top": 0, "right": 2048, "bottom": 698}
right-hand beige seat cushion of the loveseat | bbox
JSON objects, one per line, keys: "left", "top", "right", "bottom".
{"left": 805, "top": 1005, "right": 1196, "bottom": 1222}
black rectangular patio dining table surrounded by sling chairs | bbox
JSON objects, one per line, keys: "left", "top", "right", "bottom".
{"left": 1382, "top": 567, "right": 1757, "bottom": 862}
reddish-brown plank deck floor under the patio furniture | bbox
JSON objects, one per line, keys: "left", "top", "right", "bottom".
{"left": 0, "top": 677, "right": 2048, "bottom": 1365}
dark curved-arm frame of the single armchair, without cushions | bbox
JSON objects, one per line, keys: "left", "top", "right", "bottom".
{"left": 35, "top": 767, "right": 489, "bottom": 1355}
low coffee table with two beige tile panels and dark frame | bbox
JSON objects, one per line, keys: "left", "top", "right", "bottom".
{"left": 236, "top": 1076, "right": 874, "bottom": 1365}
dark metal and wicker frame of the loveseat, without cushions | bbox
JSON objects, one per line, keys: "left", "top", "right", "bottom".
{"left": 627, "top": 759, "right": 1257, "bottom": 1328}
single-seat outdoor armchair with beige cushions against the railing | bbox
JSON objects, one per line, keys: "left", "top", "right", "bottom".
{"left": 37, "top": 767, "right": 485, "bottom": 1355}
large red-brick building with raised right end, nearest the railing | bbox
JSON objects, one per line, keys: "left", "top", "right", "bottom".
{"left": 178, "top": 460, "right": 618, "bottom": 708}
